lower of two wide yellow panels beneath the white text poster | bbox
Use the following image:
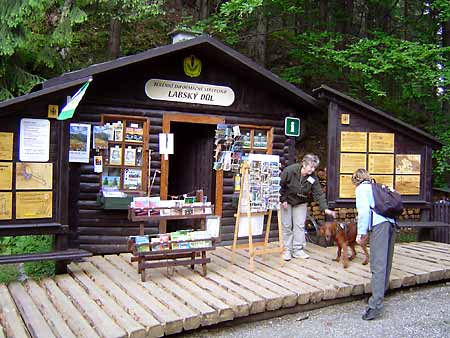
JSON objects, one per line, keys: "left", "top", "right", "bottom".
{"left": 16, "top": 191, "right": 53, "bottom": 219}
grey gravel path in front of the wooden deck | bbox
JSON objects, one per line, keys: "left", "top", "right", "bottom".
{"left": 179, "top": 282, "right": 450, "bottom": 338}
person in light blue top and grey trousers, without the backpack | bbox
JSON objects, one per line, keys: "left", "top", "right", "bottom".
{"left": 352, "top": 169, "right": 396, "bottom": 320}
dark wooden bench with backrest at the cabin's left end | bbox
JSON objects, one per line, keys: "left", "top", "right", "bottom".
{"left": 0, "top": 223, "right": 92, "bottom": 273}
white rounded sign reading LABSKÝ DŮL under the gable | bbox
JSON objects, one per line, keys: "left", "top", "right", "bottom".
{"left": 145, "top": 79, "right": 234, "bottom": 107}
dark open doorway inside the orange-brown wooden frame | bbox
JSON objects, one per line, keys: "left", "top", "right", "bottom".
{"left": 167, "top": 121, "right": 216, "bottom": 231}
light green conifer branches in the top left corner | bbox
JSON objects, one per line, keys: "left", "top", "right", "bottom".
{"left": 0, "top": 0, "right": 86, "bottom": 100}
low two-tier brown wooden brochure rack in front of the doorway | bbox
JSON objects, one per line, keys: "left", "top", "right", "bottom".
{"left": 128, "top": 205, "right": 216, "bottom": 282}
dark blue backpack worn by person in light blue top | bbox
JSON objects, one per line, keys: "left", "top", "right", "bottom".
{"left": 370, "top": 179, "right": 403, "bottom": 218}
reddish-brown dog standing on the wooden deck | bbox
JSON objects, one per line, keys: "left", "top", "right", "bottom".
{"left": 319, "top": 221, "right": 369, "bottom": 268}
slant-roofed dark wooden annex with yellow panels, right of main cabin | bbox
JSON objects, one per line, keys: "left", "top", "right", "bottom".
{"left": 314, "top": 85, "right": 442, "bottom": 221}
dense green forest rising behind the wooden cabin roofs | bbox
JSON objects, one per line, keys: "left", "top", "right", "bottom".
{"left": 0, "top": 0, "right": 450, "bottom": 188}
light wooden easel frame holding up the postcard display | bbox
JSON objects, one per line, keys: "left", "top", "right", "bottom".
{"left": 231, "top": 162, "right": 283, "bottom": 272}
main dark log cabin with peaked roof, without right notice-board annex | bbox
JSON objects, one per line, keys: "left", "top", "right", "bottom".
{"left": 0, "top": 35, "right": 320, "bottom": 253}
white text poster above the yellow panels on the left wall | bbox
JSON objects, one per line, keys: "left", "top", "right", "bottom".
{"left": 19, "top": 119, "right": 50, "bottom": 162}
